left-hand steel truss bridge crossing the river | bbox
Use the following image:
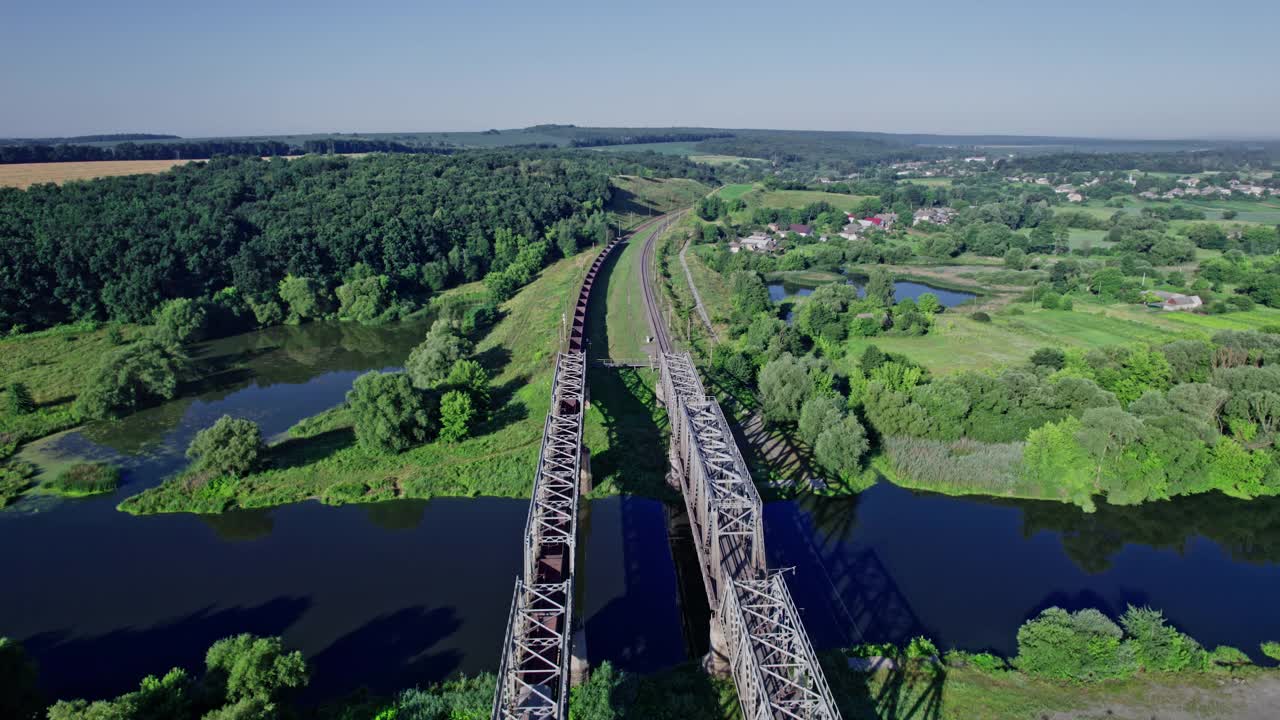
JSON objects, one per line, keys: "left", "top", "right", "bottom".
{"left": 493, "top": 352, "right": 586, "bottom": 720}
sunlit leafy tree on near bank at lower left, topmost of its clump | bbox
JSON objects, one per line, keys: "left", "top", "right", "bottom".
{"left": 205, "top": 633, "right": 307, "bottom": 703}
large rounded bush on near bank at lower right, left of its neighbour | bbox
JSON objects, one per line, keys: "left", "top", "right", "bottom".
{"left": 1014, "top": 607, "right": 1137, "bottom": 682}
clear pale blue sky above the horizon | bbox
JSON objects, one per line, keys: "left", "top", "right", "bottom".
{"left": 0, "top": 0, "right": 1280, "bottom": 137}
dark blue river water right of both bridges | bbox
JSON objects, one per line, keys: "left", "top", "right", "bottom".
{"left": 764, "top": 483, "right": 1280, "bottom": 660}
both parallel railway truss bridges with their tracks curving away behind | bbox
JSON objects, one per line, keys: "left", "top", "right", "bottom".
{"left": 493, "top": 217, "right": 840, "bottom": 720}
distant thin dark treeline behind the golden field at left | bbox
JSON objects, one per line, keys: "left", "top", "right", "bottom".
{"left": 0, "top": 138, "right": 452, "bottom": 164}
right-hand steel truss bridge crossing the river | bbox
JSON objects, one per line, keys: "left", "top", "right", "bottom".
{"left": 659, "top": 354, "right": 840, "bottom": 720}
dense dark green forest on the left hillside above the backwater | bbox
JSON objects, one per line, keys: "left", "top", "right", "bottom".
{"left": 0, "top": 151, "right": 708, "bottom": 329}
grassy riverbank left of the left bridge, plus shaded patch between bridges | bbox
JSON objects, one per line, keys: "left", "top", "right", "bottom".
{"left": 120, "top": 252, "right": 664, "bottom": 515}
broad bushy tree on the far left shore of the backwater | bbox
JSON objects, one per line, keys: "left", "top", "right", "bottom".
{"left": 76, "top": 338, "right": 186, "bottom": 419}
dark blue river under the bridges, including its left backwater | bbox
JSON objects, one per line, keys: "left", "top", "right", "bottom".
{"left": 0, "top": 319, "right": 1280, "bottom": 697}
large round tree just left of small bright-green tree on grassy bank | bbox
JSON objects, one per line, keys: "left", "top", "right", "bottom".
{"left": 347, "top": 370, "right": 435, "bottom": 452}
